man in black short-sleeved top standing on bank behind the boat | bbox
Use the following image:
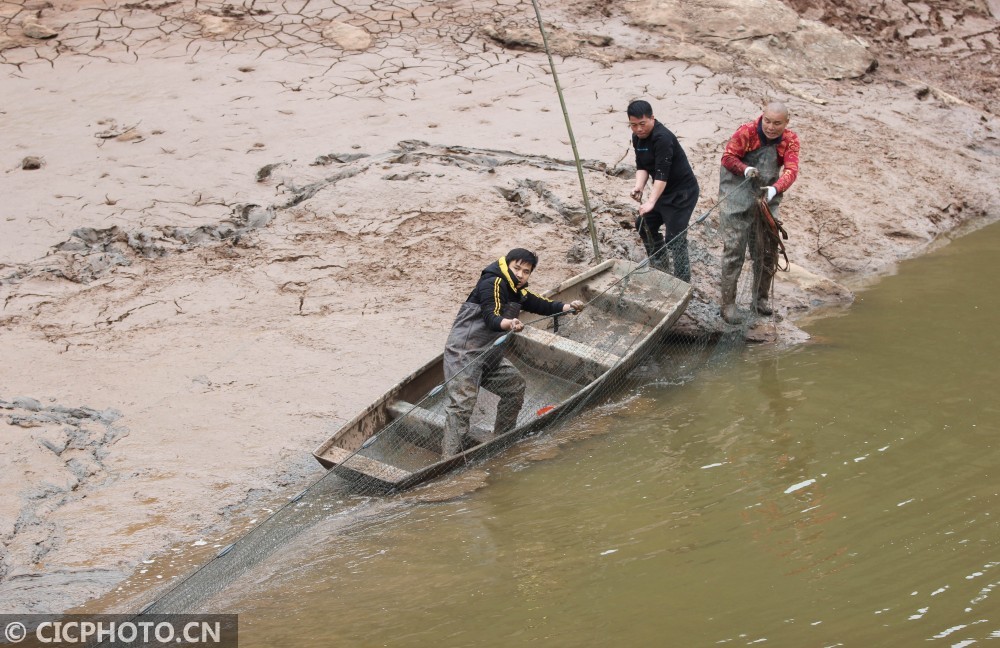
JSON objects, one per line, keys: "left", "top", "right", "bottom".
{"left": 625, "top": 100, "right": 699, "bottom": 283}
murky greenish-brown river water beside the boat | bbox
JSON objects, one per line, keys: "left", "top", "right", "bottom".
{"left": 119, "top": 224, "right": 1000, "bottom": 647}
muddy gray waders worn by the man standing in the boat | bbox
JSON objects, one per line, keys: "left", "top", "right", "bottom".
{"left": 441, "top": 302, "right": 525, "bottom": 457}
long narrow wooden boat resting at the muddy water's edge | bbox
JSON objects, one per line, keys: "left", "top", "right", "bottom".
{"left": 313, "top": 260, "right": 691, "bottom": 492}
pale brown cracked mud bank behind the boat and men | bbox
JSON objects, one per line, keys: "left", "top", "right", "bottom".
{"left": 0, "top": 0, "right": 1000, "bottom": 612}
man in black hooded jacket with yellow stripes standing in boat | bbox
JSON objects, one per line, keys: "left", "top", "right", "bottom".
{"left": 441, "top": 248, "right": 584, "bottom": 457}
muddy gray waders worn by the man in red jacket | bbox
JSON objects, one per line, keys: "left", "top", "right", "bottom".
{"left": 719, "top": 144, "right": 782, "bottom": 324}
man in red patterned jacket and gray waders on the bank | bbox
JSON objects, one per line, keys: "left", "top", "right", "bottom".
{"left": 719, "top": 101, "right": 799, "bottom": 324}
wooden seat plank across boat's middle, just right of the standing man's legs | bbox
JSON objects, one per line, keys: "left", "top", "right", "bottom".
{"left": 518, "top": 326, "right": 621, "bottom": 382}
